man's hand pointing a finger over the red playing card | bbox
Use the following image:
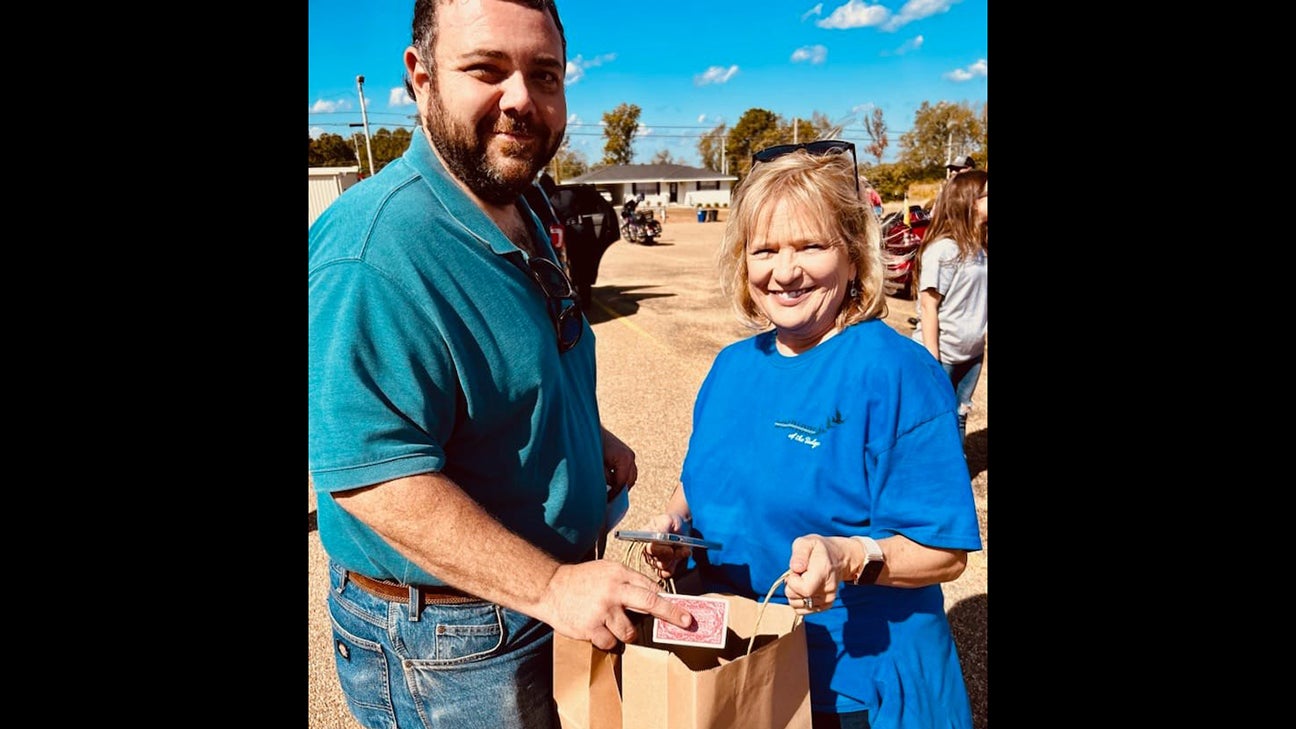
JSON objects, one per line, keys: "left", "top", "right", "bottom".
{"left": 538, "top": 559, "right": 693, "bottom": 650}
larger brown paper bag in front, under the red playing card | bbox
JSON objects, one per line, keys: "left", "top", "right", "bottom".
{"left": 619, "top": 579, "right": 810, "bottom": 729}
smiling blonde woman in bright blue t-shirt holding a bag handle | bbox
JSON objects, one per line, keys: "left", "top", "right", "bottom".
{"left": 644, "top": 141, "right": 981, "bottom": 729}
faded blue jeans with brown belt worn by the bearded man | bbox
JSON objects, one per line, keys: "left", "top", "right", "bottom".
{"left": 328, "top": 563, "right": 559, "bottom": 729}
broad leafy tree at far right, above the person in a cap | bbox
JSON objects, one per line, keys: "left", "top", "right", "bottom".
{"left": 899, "top": 101, "right": 986, "bottom": 179}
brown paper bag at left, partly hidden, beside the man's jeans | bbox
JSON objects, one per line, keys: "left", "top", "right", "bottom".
{"left": 553, "top": 633, "right": 621, "bottom": 729}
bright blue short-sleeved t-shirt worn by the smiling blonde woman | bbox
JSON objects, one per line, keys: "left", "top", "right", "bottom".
{"left": 680, "top": 319, "right": 981, "bottom": 729}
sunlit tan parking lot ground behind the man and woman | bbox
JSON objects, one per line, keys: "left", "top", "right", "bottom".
{"left": 307, "top": 208, "right": 989, "bottom": 729}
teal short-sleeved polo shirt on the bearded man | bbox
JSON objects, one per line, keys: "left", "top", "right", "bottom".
{"left": 307, "top": 131, "right": 607, "bottom": 585}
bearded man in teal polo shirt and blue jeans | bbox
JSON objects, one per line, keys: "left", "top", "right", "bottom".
{"left": 308, "top": 0, "right": 692, "bottom": 729}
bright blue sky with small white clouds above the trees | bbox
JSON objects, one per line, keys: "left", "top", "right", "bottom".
{"left": 307, "top": 0, "right": 989, "bottom": 165}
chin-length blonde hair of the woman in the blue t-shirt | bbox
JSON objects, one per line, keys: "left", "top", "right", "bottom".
{"left": 719, "top": 149, "right": 886, "bottom": 329}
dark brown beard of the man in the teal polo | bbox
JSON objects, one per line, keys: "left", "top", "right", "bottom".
{"left": 424, "top": 95, "right": 562, "bottom": 205}
